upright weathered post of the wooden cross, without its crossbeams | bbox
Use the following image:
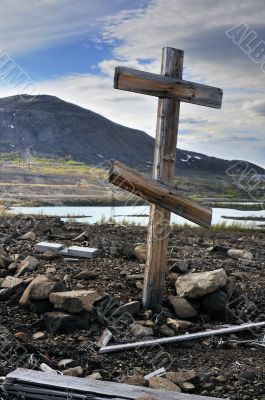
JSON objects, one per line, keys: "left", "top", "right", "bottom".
{"left": 143, "top": 47, "right": 184, "bottom": 311}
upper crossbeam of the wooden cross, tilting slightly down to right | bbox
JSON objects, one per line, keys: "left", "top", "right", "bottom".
{"left": 114, "top": 67, "right": 223, "bottom": 108}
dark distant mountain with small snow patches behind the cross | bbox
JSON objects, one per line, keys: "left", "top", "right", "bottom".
{"left": 0, "top": 95, "right": 264, "bottom": 174}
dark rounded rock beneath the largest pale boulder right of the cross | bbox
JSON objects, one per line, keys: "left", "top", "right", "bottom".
{"left": 202, "top": 290, "right": 229, "bottom": 322}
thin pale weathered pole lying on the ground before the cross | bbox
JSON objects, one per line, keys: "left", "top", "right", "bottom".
{"left": 99, "top": 321, "right": 265, "bottom": 354}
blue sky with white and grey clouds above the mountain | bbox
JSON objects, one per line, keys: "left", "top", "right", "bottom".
{"left": 0, "top": 0, "right": 265, "bottom": 167}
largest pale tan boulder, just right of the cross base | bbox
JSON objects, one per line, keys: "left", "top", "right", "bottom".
{"left": 176, "top": 268, "right": 227, "bottom": 299}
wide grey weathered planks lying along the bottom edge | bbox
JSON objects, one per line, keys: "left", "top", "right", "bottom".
{"left": 4, "top": 368, "right": 220, "bottom": 400}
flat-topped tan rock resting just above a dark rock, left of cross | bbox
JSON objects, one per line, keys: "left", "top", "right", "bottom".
{"left": 49, "top": 289, "right": 101, "bottom": 313}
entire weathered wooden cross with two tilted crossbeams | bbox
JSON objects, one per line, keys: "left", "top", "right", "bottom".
{"left": 110, "top": 47, "right": 223, "bottom": 311}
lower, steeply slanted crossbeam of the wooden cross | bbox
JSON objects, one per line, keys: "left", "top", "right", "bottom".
{"left": 109, "top": 161, "right": 212, "bottom": 228}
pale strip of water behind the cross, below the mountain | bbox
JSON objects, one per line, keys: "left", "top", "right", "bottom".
{"left": 11, "top": 205, "right": 265, "bottom": 226}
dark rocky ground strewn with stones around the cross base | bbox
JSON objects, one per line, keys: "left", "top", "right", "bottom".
{"left": 0, "top": 216, "right": 265, "bottom": 400}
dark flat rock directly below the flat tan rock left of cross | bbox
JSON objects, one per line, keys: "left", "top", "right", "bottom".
{"left": 43, "top": 312, "right": 91, "bottom": 333}
